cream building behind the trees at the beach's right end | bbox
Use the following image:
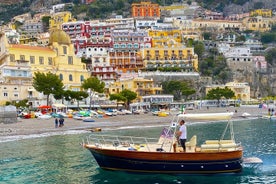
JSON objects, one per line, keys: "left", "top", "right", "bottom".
{"left": 205, "top": 82, "right": 250, "bottom": 101}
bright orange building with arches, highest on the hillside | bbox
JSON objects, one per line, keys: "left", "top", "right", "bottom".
{"left": 131, "top": 1, "right": 160, "bottom": 18}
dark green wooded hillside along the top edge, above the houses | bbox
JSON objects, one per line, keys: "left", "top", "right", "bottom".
{"left": 0, "top": 0, "right": 276, "bottom": 22}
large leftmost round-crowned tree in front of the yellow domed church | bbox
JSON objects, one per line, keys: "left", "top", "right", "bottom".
{"left": 33, "top": 72, "right": 64, "bottom": 105}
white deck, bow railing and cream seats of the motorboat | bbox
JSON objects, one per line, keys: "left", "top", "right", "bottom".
{"left": 83, "top": 135, "right": 241, "bottom": 153}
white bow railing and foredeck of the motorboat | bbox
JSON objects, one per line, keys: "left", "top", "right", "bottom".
{"left": 84, "top": 134, "right": 162, "bottom": 151}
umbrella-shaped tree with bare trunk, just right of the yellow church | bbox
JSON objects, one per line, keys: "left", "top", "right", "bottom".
{"left": 82, "top": 77, "right": 105, "bottom": 109}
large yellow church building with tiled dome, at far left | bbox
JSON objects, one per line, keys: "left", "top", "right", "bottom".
{"left": 0, "top": 30, "right": 90, "bottom": 107}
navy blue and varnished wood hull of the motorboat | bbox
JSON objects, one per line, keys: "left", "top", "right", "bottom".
{"left": 87, "top": 147, "right": 242, "bottom": 174}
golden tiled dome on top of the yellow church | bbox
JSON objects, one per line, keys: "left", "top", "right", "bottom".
{"left": 49, "top": 29, "right": 71, "bottom": 45}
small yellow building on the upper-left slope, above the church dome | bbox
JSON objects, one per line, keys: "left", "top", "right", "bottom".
{"left": 49, "top": 11, "right": 76, "bottom": 30}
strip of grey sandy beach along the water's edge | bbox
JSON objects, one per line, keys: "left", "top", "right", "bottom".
{"left": 0, "top": 106, "right": 267, "bottom": 139}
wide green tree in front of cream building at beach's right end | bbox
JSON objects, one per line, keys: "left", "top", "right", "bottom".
{"left": 206, "top": 87, "right": 235, "bottom": 105}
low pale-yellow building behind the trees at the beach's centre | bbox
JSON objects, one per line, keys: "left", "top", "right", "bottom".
{"left": 107, "top": 78, "right": 162, "bottom": 102}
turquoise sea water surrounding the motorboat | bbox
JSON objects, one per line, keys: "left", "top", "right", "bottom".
{"left": 0, "top": 120, "right": 276, "bottom": 184}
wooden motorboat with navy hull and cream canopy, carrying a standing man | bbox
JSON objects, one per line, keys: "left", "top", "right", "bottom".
{"left": 82, "top": 113, "right": 248, "bottom": 174}
